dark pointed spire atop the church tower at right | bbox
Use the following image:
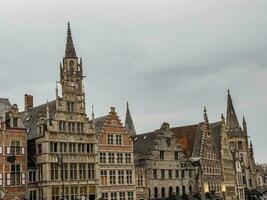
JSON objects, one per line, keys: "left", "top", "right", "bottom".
{"left": 226, "top": 89, "right": 240, "bottom": 130}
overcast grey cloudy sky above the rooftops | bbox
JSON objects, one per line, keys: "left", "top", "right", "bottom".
{"left": 0, "top": 0, "right": 267, "bottom": 162}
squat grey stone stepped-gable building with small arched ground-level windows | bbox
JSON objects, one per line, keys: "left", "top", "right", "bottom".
{"left": 132, "top": 122, "right": 196, "bottom": 199}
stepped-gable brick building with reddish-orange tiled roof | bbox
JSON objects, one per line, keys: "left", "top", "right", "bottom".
{"left": 172, "top": 108, "right": 222, "bottom": 197}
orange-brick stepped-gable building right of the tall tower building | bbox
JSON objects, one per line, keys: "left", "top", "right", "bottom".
{"left": 93, "top": 107, "right": 136, "bottom": 200}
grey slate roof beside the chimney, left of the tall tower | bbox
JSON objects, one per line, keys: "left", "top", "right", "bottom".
{"left": 20, "top": 100, "right": 56, "bottom": 140}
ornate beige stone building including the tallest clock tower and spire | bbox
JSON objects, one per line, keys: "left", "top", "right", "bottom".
{"left": 22, "top": 24, "right": 98, "bottom": 200}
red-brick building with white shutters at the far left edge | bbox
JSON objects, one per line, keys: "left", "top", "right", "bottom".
{"left": 0, "top": 101, "right": 27, "bottom": 200}
